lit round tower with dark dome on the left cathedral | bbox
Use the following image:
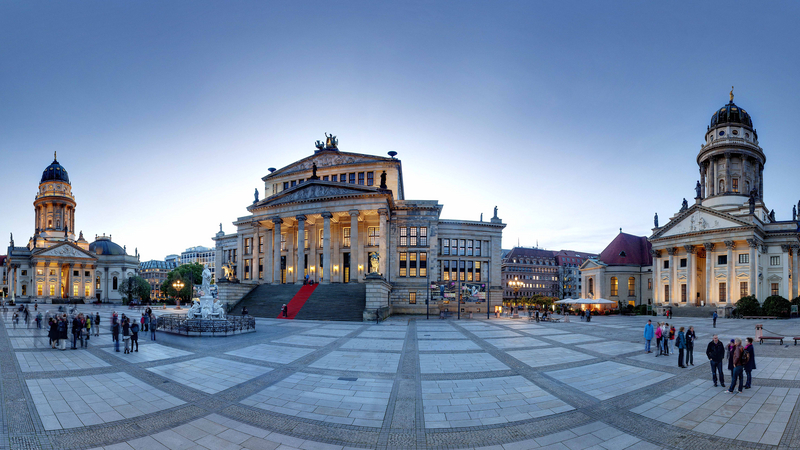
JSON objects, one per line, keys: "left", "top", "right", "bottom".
{"left": 33, "top": 153, "right": 77, "bottom": 248}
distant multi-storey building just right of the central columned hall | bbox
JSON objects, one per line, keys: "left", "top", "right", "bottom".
{"left": 500, "top": 247, "right": 559, "bottom": 300}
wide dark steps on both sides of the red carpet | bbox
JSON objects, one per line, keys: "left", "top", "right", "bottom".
{"left": 233, "top": 283, "right": 367, "bottom": 322}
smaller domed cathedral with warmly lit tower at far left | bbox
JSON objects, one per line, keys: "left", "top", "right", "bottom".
{"left": 5, "top": 155, "right": 139, "bottom": 303}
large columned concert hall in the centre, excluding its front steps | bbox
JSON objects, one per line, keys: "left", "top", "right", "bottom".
{"left": 213, "top": 136, "right": 505, "bottom": 313}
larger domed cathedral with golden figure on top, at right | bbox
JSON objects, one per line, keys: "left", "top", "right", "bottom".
{"left": 650, "top": 90, "right": 800, "bottom": 309}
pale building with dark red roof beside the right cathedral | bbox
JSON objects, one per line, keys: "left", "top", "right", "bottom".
{"left": 580, "top": 232, "right": 653, "bottom": 306}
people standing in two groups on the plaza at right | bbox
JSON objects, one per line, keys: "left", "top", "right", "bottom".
{"left": 644, "top": 313, "right": 756, "bottom": 393}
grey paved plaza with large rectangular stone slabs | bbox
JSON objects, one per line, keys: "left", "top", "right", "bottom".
{"left": 0, "top": 306, "right": 800, "bottom": 450}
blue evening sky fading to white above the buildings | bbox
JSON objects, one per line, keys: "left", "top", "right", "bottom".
{"left": 0, "top": 0, "right": 800, "bottom": 261}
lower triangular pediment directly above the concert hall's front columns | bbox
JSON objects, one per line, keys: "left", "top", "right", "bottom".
{"left": 247, "top": 180, "right": 391, "bottom": 211}
